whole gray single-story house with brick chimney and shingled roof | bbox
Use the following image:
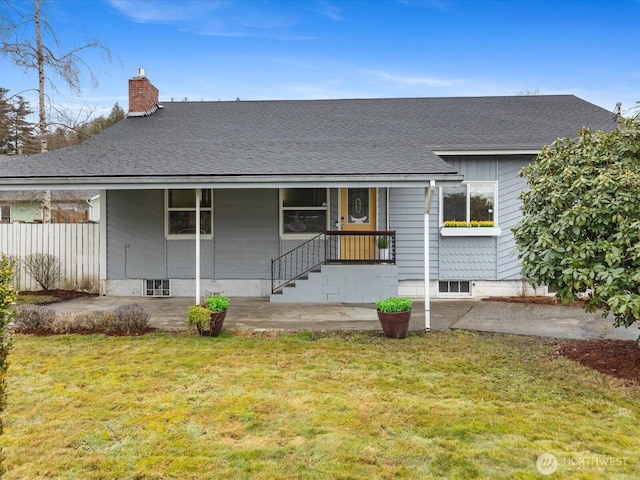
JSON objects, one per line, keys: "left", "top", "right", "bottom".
{"left": 0, "top": 73, "right": 616, "bottom": 303}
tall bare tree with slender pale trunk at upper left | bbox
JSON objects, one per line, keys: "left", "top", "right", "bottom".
{"left": 0, "top": 0, "right": 111, "bottom": 223}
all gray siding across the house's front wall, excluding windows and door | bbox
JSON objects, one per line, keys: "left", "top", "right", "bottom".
{"left": 106, "top": 155, "right": 532, "bottom": 288}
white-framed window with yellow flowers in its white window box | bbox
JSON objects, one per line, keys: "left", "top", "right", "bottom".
{"left": 440, "top": 182, "right": 501, "bottom": 236}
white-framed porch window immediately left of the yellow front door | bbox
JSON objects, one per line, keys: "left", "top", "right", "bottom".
{"left": 280, "top": 188, "right": 328, "bottom": 235}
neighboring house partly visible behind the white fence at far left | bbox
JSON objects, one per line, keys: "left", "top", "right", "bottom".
{"left": 0, "top": 189, "right": 100, "bottom": 223}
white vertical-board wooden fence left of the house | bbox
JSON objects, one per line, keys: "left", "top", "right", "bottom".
{"left": 0, "top": 223, "right": 100, "bottom": 292}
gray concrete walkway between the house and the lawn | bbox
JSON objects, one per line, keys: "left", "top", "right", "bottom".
{"left": 51, "top": 297, "right": 640, "bottom": 340}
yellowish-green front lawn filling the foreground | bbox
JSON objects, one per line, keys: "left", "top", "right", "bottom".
{"left": 0, "top": 332, "right": 640, "bottom": 479}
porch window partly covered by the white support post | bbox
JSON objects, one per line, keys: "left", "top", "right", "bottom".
{"left": 166, "top": 188, "right": 213, "bottom": 238}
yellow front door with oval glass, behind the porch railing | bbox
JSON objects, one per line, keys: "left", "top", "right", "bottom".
{"left": 340, "top": 188, "right": 376, "bottom": 260}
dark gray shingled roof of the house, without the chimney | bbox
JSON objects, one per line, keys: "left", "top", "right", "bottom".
{"left": 0, "top": 95, "right": 615, "bottom": 188}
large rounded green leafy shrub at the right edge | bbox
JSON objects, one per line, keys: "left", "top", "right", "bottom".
{"left": 513, "top": 119, "right": 640, "bottom": 327}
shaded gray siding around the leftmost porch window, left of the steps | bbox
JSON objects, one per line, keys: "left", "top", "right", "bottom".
{"left": 106, "top": 189, "right": 279, "bottom": 280}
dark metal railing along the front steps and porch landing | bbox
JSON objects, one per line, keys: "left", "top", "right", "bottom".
{"left": 271, "top": 230, "right": 396, "bottom": 293}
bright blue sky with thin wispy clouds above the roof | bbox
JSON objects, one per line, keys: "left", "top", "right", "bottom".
{"left": 0, "top": 0, "right": 640, "bottom": 119}
